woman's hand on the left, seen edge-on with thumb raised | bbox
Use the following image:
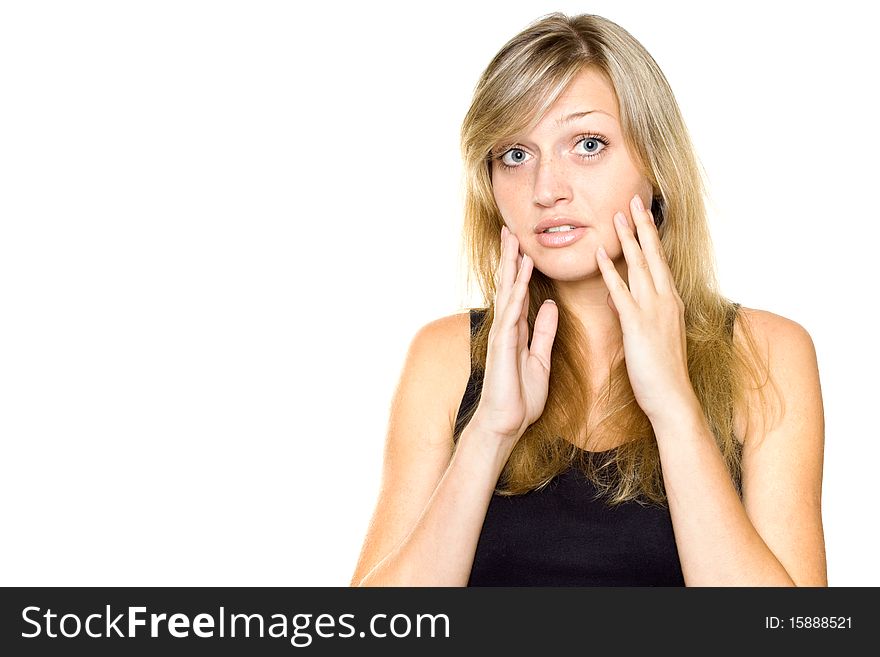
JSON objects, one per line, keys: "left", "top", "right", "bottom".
{"left": 472, "top": 226, "right": 559, "bottom": 445}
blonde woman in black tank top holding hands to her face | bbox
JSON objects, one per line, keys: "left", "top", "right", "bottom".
{"left": 352, "top": 14, "right": 827, "bottom": 586}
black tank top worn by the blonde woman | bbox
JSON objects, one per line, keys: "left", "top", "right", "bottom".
{"left": 454, "top": 304, "right": 739, "bottom": 586}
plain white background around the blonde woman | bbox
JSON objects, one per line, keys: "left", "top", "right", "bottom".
{"left": 0, "top": 0, "right": 880, "bottom": 586}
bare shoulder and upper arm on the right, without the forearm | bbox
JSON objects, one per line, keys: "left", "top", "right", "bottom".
{"left": 728, "top": 308, "right": 827, "bottom": 586}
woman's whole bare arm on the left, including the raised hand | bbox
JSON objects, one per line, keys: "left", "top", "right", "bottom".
{"left": 352, "top": 229, "right": 557, "bottom": 586}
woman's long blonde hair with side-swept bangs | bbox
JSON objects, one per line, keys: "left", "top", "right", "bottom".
{"left": 461, "top": 12, "right": 775, "bottom": 505}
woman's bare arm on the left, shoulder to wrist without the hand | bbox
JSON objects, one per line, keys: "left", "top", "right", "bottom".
{"left": 351, "top": 314, "right": 512, "bottom": 586}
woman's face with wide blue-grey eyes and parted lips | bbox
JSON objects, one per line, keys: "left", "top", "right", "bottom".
{"left": 491, "top": 70, "right": 652, "bottom": 281}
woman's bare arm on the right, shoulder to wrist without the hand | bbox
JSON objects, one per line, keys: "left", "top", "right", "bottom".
{"left": 655, "top": 311, "right": 827, "bottom": 586}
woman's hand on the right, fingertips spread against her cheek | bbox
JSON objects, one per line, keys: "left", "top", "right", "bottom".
{"left": 596, "top": 195, "right": 696, "bottom": 423}
